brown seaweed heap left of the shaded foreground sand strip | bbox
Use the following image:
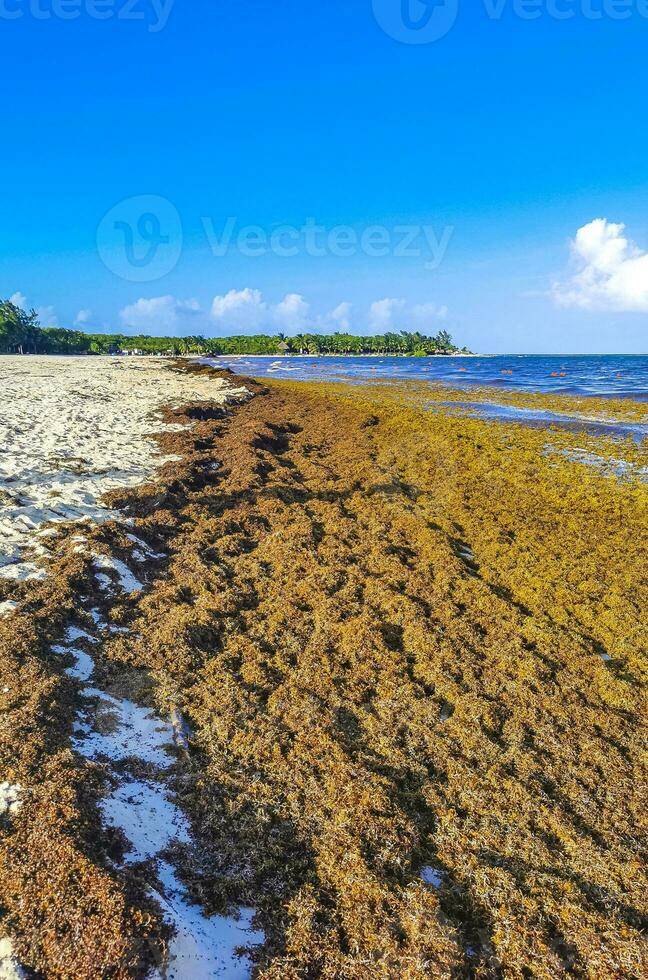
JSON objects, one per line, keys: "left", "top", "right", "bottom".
{"left": 0, "top": 548, "right": 164, "bottom": 980}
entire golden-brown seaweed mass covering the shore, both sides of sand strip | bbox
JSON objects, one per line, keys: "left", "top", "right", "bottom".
{"left": 0, "top": 368, "right": 648, "bottom": 980}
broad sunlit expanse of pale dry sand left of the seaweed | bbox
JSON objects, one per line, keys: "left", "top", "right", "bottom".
{"left": 0, "top": 356, "right": 246, "bottom": 588}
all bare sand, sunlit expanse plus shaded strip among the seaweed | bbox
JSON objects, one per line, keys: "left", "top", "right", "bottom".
{"left": 0, "top": 357, "right": 263, "bottom": 980}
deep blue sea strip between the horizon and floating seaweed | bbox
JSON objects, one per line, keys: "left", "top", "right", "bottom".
{"left": 209, "top": 354, "right": 648, "bottom": 400}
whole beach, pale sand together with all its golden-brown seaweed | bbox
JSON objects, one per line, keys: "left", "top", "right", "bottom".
{"left": 0, "top": 358, "right": 648, "bottom": 980}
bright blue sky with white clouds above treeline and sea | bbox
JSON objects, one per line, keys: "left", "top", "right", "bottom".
{"left": 0, "top": 0, "right": 648, "bottom": 353}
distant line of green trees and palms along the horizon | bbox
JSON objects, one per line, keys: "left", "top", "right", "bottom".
{"left": 0, "top": 301, "right": 466, "bottom": 357}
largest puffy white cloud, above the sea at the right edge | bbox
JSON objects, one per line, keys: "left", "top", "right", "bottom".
{"left": 553, "top": 218, "right": 648, "bottom": 313}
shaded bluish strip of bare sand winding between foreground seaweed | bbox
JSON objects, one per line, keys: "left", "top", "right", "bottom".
{"left": 60, "top": 628, "right": 264, "bottom": 980}
